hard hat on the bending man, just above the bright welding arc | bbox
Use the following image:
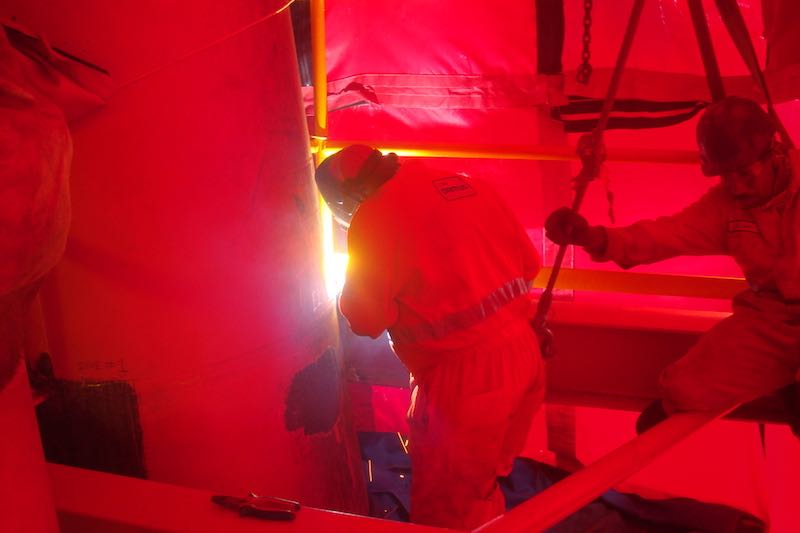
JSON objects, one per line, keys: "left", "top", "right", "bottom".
{"left": 315, "top": 144, "right": 382, "bottom": 227}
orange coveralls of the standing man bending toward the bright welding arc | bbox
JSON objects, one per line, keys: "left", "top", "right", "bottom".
{"left": 339, "top": 161, "right": 544, "bottom": 529}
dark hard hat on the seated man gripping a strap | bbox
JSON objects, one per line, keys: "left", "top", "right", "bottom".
{"left": 697, "top": 96, "right": 776, "bottom": 176}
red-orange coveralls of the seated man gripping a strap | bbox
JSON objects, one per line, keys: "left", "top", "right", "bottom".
{"left": 595, "top": 152, "right": 800, "bottom": 412}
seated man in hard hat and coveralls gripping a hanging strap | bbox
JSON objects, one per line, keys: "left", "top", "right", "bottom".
{"left": 545, "top": 96, "right": 800, "bottom": 431}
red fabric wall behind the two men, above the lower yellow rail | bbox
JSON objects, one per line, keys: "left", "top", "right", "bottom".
{"left": 312, "top": 0, "right": 800, "bottom": 276}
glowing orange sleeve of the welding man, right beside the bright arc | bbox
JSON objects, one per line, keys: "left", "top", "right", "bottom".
{"left": 339, "top": 205, "right": 399, "bottom": 338}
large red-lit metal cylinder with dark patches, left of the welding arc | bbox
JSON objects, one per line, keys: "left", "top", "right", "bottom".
{"left": 2, "top": 0, "right": 365, "bottom": 512}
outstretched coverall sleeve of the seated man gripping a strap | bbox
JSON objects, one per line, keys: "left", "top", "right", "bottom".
{"left": 592, "top": 187, "right": 729, "bottom": 268}
